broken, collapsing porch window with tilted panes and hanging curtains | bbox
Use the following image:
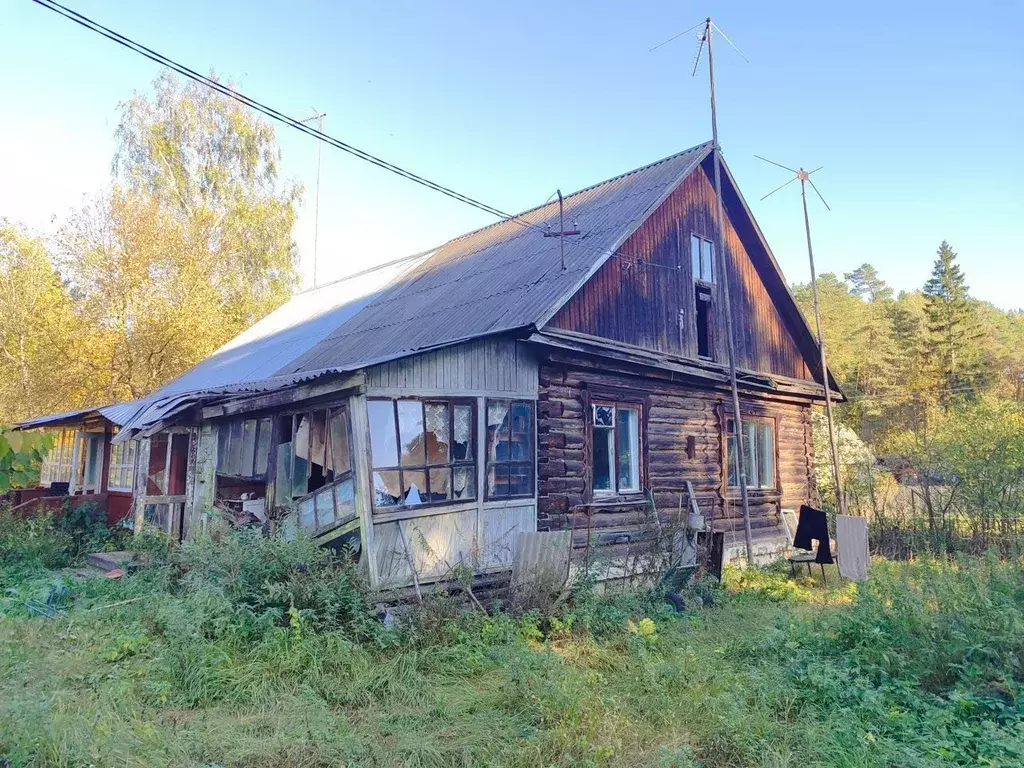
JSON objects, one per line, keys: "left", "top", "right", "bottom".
{"left": 268, "top": 406, "right": 355, "bottom": 534}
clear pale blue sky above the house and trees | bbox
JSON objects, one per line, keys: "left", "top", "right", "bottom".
{"left": 0, "top": 0, "right": 1024, "bottom": 308}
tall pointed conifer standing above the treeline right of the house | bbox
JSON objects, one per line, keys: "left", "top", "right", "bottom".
{"left": 924, "top": 241, "right": 981, "bottom": 404}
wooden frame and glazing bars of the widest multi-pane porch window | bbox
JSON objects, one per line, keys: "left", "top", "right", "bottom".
{"left": 367, "top": 395, "right": 483, "bottom": 518}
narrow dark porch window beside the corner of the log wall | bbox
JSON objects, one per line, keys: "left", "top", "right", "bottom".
{"left": 486, "top": 400, "right": 535, "bottom": 499}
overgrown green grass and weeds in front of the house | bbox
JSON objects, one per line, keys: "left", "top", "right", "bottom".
{"left": 0, "top": 518, "right": 1024, "bottom": 767}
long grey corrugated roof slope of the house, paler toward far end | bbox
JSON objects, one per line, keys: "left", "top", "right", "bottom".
{"left": 105, "top": 142, "right": 712, "bottom": 436}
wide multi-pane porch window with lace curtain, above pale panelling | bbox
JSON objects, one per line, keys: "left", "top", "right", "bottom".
{"left": 367, "top": 399, "right": 476, "bottom": 512}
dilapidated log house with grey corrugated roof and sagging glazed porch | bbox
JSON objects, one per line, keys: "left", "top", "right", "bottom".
{"left": 22, "top": 143, "right": 839, "bottom": 587}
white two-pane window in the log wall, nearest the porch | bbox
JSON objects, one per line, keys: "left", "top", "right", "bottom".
{"left": 591, "top": 402, "right": 640, "bottom": 494}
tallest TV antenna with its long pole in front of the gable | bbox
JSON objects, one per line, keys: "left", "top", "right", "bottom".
{"left": 651, "top": 16, "right": 754, "bottom": 565}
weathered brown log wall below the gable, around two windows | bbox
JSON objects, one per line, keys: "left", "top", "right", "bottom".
{"left": 538, "top": 361, "right": 815, "bottom": 546}
